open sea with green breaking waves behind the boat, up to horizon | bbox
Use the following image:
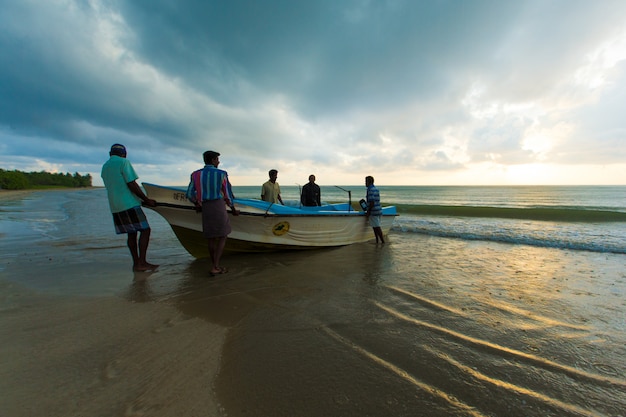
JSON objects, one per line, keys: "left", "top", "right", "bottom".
{"left": 243, "top": 186, "right": 626, "bottom": 254}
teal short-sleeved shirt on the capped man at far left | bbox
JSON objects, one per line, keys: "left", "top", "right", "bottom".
{"left": 100, "top": 155, "right": 141, "bottom": 213}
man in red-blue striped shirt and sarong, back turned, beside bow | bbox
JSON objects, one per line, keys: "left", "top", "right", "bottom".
{"left": 187, "top": 151, "right": 239, "bottom": 276}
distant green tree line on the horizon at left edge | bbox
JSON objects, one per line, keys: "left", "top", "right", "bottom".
{"left": 0, "top": 168, "right": 91, "bottom": 190}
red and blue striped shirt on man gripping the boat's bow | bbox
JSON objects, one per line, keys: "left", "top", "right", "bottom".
{"left": 187, "top": 165, "right": 234, "bottom": 205}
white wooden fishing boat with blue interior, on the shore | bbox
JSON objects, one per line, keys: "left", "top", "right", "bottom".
{"left": 142, "top": 183, "right": 398, "bottom": 258}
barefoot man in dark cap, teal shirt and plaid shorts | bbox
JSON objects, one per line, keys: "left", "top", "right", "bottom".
{"left": 100, "top": 143, "right": 158, "bottom": 272}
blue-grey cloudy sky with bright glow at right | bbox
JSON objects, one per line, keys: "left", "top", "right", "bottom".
{"left": 0, "top": 0, "right": 626, "bottom": 185}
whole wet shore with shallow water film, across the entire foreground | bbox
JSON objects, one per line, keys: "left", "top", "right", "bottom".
{"left": 0, "top": 191, "right": 626, "bottom": 417}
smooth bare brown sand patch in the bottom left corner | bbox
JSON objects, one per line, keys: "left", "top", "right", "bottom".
{"left": 0, "top": 282, "right": 225, "bottom": 417}
